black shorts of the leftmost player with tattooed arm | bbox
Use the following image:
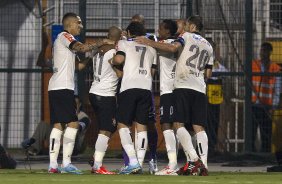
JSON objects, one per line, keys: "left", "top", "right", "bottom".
{"left": 48, "top": 89, "right": 77, "bottom": 124}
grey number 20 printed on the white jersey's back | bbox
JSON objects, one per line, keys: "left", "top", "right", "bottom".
{"left": 186, "top": 45, "right": 210, "bottom": 71}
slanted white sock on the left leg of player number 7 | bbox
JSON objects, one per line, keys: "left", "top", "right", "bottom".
{"left": 118, "top": 128, "right": 138, "bottom": 165}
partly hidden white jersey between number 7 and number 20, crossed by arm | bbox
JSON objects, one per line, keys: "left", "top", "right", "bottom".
{"left": 158, "top": 39, "right": 176, "bottom": 95}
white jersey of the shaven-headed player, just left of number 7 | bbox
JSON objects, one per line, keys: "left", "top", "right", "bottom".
{"left": 89, "top": 49, "right": 118, "bottom": 96}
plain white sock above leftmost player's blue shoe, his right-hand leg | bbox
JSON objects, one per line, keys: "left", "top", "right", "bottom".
{"left": 63, "top": 127, "right": 77, "bottom": 167}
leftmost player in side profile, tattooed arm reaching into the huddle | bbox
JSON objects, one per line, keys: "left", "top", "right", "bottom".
{"left": 48, "top": 13, "right": 111, "bottom": 174}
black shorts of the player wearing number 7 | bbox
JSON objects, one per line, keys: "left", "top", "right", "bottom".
{"left": 117, "top": 88, "right": 152, "bottom": 126}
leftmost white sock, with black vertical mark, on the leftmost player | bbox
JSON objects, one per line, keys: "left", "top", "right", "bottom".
{"left": 49, "top": 128, "right": 63, "bottom": 168}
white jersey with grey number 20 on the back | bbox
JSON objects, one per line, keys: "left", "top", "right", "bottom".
{"left": 174, "top": 32, "right": 214, "bottom": 94}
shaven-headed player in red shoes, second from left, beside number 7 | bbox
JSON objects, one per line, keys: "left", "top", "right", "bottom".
{"left": 89, "top": 26, "right": 121, "bottom": 174}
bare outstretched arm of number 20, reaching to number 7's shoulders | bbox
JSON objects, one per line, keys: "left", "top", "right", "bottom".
{"left": 134, "top": 36, "right": 182, "bottom": 53}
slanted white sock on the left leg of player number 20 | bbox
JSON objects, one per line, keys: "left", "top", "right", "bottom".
{"left": 176, "top": 127, "right": 199, "bottom": 161}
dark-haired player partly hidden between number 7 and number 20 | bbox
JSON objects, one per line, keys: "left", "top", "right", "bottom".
{"left": 155, "top": 19, "right": 178, "bottom": 175}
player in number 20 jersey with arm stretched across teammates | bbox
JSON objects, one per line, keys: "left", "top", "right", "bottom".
{"left": 136, "top": 15, "right": 213, "bottom": 175}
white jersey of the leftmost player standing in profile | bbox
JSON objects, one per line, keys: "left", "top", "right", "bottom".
{"left": 48, "top": 31, "right": 76, "bottom": 91}
